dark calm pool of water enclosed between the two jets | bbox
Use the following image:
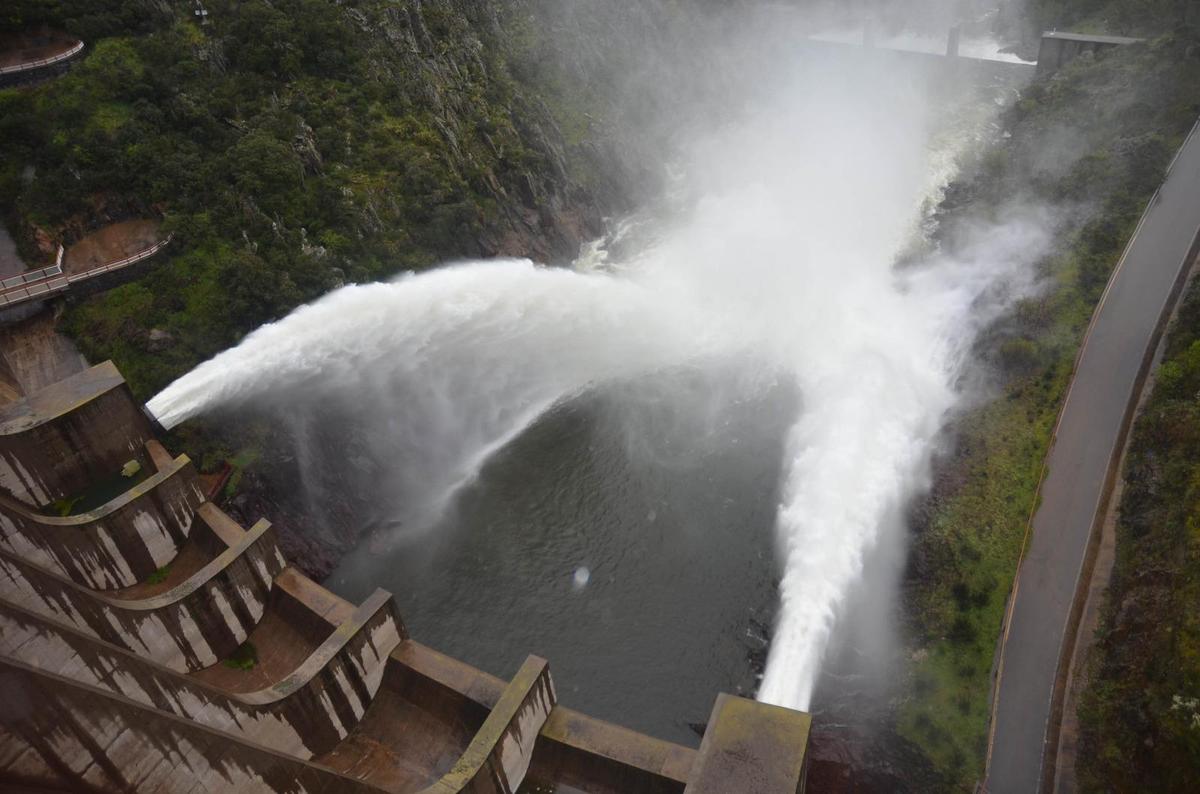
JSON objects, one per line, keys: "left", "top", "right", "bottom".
{"left": 326, "top": 369, "right": 796, "bottom": 745}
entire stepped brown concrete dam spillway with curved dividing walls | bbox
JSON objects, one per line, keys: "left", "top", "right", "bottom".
{"left": 0, "top": 362, "right": 810, "bottom": 794}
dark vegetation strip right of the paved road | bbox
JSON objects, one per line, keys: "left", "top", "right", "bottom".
{"left": 1076, "top": 266, "right": 1200, "bottom": 792}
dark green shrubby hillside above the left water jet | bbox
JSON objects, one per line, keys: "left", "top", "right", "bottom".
{"left": 0, "top": 0, "right": 596, "bottom": 397}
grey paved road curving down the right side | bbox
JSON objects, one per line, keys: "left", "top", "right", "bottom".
{"left": 988, "top": 119, "right": 1200, "bottom": 794}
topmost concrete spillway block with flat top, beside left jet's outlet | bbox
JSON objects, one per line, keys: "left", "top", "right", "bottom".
{"left": 0, "top": 361, "right": 154, "bottom": 506}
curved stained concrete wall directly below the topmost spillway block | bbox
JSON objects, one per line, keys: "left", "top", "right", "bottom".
{"left": 0, "top": 441, "right": 204, "bottom": 590}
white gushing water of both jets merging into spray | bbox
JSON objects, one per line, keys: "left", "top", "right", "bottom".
{"left": 149, "top": 34, "right": 1045, "bottom": 708}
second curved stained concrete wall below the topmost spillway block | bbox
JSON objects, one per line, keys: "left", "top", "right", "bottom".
{"left": 0, "top": 521, "right": 286, "bottom": 672}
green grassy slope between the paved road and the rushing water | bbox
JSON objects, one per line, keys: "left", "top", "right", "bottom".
{"left": 896, "top": 34, "right": 1200, "bottom": 789}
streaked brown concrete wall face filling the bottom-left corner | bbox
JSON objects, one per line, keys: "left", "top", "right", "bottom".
{"left": 0, "top": 657, "right": 382, "bottom": 794}
